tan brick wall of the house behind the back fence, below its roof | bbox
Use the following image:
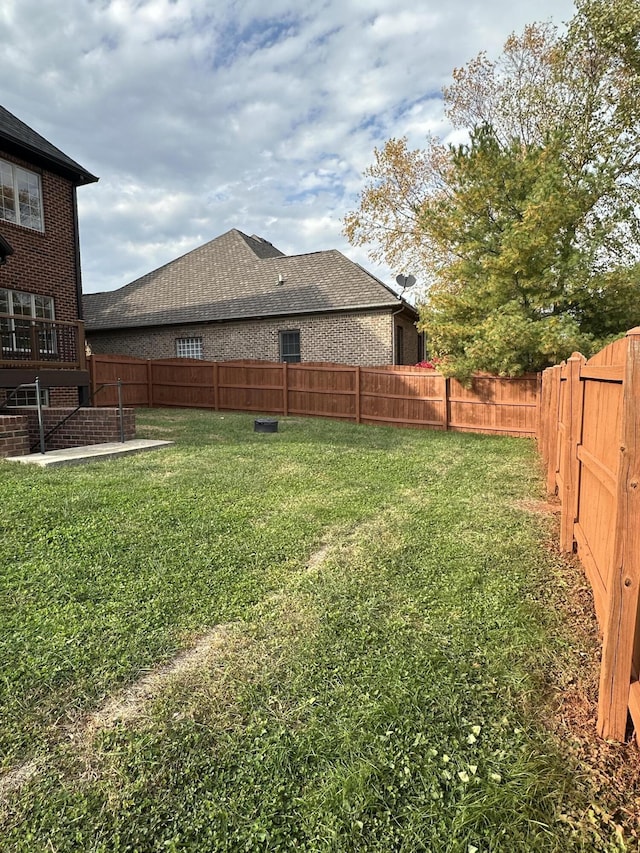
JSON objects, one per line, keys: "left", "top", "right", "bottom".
{"left": 87, "top": 311, "right": 418, "bottom": 367}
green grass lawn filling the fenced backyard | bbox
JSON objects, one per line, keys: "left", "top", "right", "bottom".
{"left": 0, "top": 410, "right": 635, "bottom": 853}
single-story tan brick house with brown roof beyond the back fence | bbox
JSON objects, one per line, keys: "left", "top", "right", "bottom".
{"left": 83, "top": 229, "right": 423, "bottom": 365}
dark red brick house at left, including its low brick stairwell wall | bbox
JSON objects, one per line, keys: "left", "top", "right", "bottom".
{"left": 0, "top": 107, "right": 135, "bottom": 457}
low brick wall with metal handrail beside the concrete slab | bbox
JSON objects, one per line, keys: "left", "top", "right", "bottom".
{"left": 20, "top": 407, "right": 136, "bottom": 450}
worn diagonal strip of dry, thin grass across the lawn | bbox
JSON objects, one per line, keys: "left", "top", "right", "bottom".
{"left": 0, "top": 510, "right": 395, "bottom": 799}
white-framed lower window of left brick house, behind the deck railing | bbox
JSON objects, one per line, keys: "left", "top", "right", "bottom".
{"left": 0, "top": 289, "right": 57, "bottom": 358}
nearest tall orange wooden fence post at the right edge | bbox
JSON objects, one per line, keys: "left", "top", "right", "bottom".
{"left": 598, "top": 327, "right": 640, "bottom": 740}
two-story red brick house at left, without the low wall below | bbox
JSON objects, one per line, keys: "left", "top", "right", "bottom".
{"left": 0, "top": 107, "right": 98, "bottom": 405}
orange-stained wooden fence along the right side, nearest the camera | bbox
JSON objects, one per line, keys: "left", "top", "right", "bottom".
{"left": 539, "top": 328, "right": 640, "bottom": 740}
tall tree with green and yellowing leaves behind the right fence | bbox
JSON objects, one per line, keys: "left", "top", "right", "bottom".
{"left": 345, "top": 0, "right": 640, "bottom": 377}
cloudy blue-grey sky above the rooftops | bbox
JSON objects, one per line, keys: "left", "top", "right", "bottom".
{"left": 0, "top": 0, "right": 574, "bottom": 292}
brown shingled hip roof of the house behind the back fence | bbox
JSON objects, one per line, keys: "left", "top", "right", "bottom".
{"left": 83, "top": 228, "right": 415, "bottom": 331}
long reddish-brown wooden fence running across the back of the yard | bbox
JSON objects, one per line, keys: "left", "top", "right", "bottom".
{"left": 89, "top": 355, "right": 538, "bottom": 437}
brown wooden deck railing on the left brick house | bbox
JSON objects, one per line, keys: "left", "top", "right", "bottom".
{"left": 0, "top": 314, "right": 86, "bottom": 370}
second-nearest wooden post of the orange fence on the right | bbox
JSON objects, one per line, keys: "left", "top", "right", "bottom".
{"left": 560, "top": 352, "right": 584, "bottom": 552}
